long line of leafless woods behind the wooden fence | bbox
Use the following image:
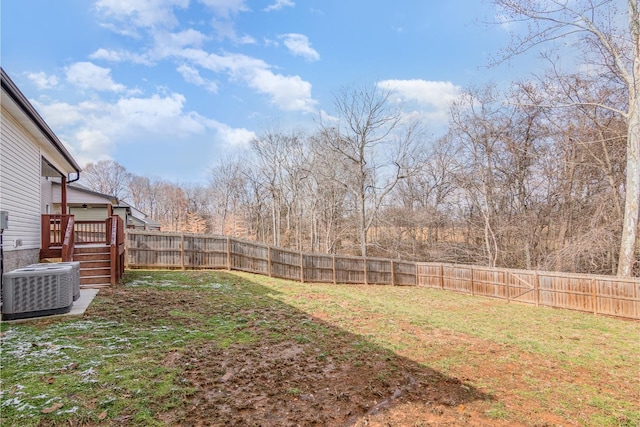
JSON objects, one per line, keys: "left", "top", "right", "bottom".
{"left": 83, "top": 76, "right": 638, "bottom": 275}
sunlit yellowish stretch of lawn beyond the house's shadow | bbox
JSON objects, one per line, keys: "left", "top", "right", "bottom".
{"left": 238, "top": 273, "right": 640, "bottom": 426}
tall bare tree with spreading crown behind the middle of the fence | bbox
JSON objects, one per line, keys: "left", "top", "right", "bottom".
{"left": 321, "top": 86, "right": 423, "bottom": 256}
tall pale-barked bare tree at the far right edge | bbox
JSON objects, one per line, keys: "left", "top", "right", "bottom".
{"left": 494, "top": 0, "right": 640, "bottom": 276}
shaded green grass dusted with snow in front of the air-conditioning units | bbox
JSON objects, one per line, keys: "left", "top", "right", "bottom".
{"left": 1, "top": 320, "right": 188, "bottom": 425}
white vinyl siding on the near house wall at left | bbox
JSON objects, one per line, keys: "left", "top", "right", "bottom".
{"left": 0, "top": 109, "right": 41, "bottom": 251}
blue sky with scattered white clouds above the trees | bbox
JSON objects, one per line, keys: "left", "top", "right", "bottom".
{"left": 0, "top": 0, "right": 533, "bottom": 183}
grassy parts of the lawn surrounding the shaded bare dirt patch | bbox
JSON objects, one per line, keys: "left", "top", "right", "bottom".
{"left": 0, "top": 271, "right": 640, "bottom": 426}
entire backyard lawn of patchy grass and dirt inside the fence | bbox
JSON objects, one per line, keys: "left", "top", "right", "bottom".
{"left": 0, "top": 270, "right": 640, "bottom": 427}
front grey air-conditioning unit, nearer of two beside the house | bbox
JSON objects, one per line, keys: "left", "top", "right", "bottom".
{"left": 2, "top": 265, "right": 75, "bottom": 320}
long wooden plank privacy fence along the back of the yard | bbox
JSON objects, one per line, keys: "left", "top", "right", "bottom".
{"left": 126, "top": 230, "right": 640, "bottom": 319}
